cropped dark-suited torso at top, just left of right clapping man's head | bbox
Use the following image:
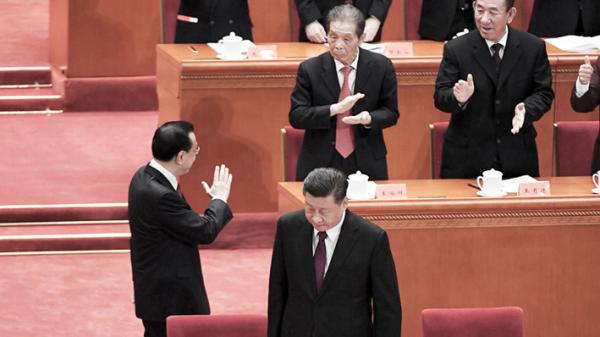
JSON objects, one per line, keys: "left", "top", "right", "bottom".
{"left": 419, "top": 0, "right": 475, "bottom": 41}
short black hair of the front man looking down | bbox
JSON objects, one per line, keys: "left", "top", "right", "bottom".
{"left": 302, "top": 167, "right": 348, "bottom": 204}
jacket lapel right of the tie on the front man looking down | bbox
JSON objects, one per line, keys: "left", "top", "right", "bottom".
{"left": 313, "top": 211, "right": 358, "bottom": 294}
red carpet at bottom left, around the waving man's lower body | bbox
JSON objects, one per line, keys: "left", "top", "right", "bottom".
{"left": 0, "top": 249, "right": 271, "bottom": 337}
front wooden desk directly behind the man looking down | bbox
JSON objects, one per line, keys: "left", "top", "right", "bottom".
{"left": 278, "top": 177, "right": 600, "bottom": 337}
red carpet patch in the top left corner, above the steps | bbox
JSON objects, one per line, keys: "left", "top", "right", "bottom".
{"left": 0, "top": 0, "right": 49, "bottom": 67}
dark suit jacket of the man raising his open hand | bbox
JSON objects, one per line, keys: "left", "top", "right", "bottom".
{"left": 129, "top": 165, "right": 232, "bottom": 321}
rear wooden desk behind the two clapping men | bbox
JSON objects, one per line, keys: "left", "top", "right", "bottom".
{"left": 157, "top": 41, "right": 598, "bottom": 211}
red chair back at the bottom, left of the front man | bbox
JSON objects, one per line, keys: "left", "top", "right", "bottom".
{"left": 167, "top": 315, "right": 267, "bottom": 337}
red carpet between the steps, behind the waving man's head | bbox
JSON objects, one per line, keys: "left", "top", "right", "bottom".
{"left": 0, "top": 111, "right": 158, "bottom": 205}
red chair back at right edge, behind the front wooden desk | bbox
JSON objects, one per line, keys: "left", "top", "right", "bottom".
{"left": 554, "top": 121, "right": 599, "bottom": 176}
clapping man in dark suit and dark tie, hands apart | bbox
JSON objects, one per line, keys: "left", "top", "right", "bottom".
{"left": 434, "top": 0, "right": 554, "bottom": 178}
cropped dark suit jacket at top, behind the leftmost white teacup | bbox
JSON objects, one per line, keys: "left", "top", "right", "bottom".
{"left": 175, "top": 0, "right": 252, "bottom": 43}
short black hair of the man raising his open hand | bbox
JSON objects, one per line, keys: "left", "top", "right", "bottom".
{"left": 152, "top": 121, "right": 194, "bottom": 161}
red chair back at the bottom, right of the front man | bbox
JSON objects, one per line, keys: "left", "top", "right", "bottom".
{"left": 421, "top": 307, "right": 523, "bottom": 337}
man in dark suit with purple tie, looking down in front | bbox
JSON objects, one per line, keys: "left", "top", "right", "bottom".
{"left": 267, "top": 168, "right": 402, "bottom": 337}
